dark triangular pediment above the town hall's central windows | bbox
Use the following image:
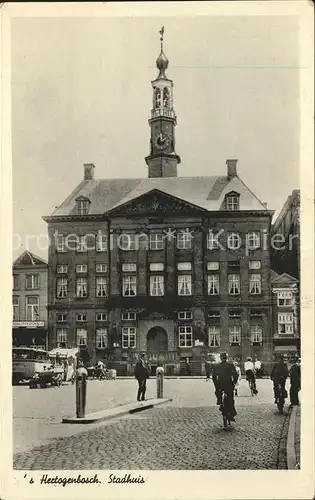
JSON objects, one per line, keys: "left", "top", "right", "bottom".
{"left": 108, "top": 189, "right": 205, "bottom": 216}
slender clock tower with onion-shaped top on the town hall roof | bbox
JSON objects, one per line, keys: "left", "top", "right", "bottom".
{"left": 145, "top": 27, "right": 180, "bottom": 177}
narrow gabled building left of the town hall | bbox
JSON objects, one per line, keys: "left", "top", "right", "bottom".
{"left": 12, "top": 251, "right": 48, "bottom": 348}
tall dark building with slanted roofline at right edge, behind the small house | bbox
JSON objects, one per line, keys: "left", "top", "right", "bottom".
{"left": 271, "top": 189, "right": 300, "bottom": 280}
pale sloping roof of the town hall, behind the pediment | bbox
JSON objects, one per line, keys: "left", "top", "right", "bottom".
{"left": 52, "top": 176, "right": 267, "bottom": 216}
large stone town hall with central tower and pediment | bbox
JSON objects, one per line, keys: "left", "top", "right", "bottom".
{"left": 44, "top": 32, "right": 273, "bottom": 374}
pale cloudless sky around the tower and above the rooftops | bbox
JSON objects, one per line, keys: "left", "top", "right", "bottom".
{"left": 11, "top": 15, "right": 301, "bottom": 258}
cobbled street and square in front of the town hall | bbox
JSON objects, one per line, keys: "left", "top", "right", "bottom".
{"left": 13, "top": 379, "right": 292, "bottom": 470}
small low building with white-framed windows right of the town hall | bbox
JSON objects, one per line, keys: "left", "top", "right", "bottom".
{"left": 271, "top": 272, "right": 300, "bottom": 356}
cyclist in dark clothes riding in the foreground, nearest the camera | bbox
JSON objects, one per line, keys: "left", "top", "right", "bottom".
{"left": 212, "top": 352, "right": 238, "bottom": 422}
